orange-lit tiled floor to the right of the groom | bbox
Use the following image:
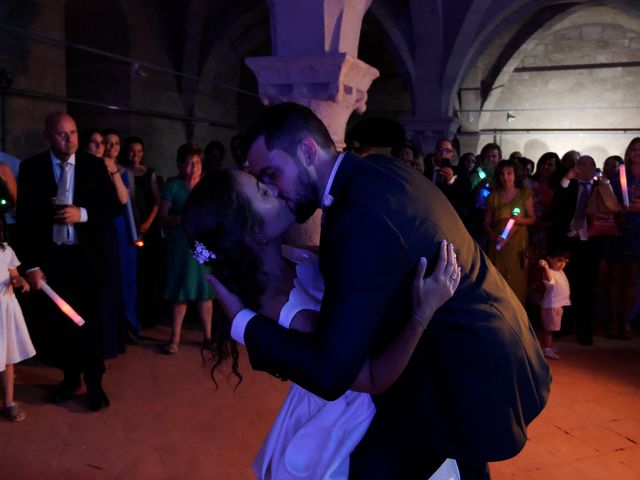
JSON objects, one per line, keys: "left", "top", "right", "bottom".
{"left": 491, "top": 337, "right": 640, "bottom": 480}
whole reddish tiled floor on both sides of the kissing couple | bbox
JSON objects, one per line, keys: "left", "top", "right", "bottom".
{"left": 0, "top": 327, "right": 640, "bottom": 480}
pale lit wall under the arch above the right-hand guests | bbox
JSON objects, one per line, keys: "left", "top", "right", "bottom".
{"left": 468, "top": 7, "right": 640, "bottom": 164}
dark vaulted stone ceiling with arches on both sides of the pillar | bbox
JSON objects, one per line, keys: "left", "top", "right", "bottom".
{"left": 0, "top": 0, "right": 640, "bottom": 163}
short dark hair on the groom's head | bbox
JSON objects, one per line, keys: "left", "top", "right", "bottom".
{"left": 243, "top": 102, "right": 336, "bottom": 156}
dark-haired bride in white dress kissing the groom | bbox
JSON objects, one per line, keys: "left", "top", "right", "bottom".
{"left": 183, "top": 170, "right": 460, "bottom": 480}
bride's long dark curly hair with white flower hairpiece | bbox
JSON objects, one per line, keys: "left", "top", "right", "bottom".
{"left": 182, "top": 170, "right": 265, "bottom": 388}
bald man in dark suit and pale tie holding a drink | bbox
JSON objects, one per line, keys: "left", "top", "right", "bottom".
{"left": 16, "top": 113, "right": 120, "bottom": 411}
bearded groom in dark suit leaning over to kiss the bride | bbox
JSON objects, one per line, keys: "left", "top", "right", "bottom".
{"left": 214, "top": 103, "right": 551, "bottom": 480}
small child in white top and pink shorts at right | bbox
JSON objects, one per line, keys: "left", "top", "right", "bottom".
{"left": 540, "top": 248, "right": 571, "bottom": 360}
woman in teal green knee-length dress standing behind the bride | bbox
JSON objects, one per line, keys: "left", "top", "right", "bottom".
{"left": 158, "top": 144, "right": 213, "bottom": 354}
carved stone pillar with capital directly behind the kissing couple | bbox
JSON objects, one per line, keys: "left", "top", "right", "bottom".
{"left": 246, "top": 0, "right": 379, "bottom": 245}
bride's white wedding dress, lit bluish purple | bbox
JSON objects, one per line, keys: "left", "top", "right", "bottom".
{"left": 253, "top": 247, "right": 460, "bottom": 480}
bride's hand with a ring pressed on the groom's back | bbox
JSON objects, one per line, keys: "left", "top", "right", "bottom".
{"left": 411, "top": 240, "right": 461, "bottom": 328}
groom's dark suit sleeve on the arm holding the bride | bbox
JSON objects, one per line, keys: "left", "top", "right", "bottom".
{"left": 244, "top": 209, "right": 424, "bottom": 400}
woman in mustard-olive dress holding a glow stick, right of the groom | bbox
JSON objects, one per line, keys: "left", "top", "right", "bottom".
{"left": 484, "top": 160, "right": 536, "bottom": 305}
